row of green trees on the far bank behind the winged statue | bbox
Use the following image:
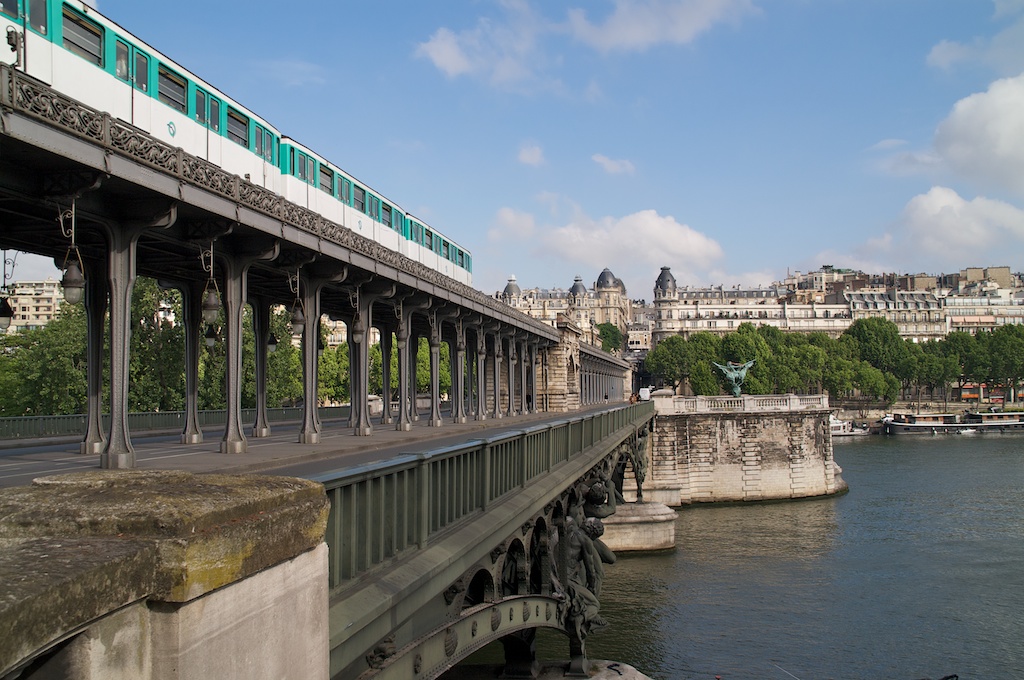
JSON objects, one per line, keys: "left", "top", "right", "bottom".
{"left": 645, "top": 317, "right": 1024, "bottom": 403}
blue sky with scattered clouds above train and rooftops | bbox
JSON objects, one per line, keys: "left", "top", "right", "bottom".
{"left": 14, "top": 0, "right": 1024, "bottom": 300}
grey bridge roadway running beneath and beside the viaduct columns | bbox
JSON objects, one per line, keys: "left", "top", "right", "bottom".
{"left": 0, "top": 405, "right": 621, "bottom": 487}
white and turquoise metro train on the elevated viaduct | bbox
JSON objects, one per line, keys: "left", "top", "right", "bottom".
{"left": 0, "top": 0, "right": 473, "bottom": 285}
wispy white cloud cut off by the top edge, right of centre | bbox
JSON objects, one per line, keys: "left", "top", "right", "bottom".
{"left": 568, "top": 0, "right": 760, "bottom": 52}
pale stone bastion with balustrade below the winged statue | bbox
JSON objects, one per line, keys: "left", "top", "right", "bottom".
{"left": 643, "top": 398, "right": 847, "bottom": 506}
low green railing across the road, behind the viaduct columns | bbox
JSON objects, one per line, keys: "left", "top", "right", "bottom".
{"left": 0, "top": 406, "right": 348, "bottom": 439}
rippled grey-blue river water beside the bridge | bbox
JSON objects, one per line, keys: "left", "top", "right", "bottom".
{"left": 573, "top": 435, "right": 1024, "bottom": 680}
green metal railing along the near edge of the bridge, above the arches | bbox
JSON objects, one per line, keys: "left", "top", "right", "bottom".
{"left": 314, "top": 401, "right": 654, "bottom": 591}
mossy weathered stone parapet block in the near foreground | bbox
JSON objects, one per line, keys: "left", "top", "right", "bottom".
{"left": 0, "top": 471, "right": 328, "bottom": 680}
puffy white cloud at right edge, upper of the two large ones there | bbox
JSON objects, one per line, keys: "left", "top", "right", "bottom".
{"left": 935, "top": 75, "right": 1024, "bottom": 197}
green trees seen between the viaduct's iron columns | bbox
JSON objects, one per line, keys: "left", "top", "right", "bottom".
{"left": 0, "top": 278, "right": 451, "bottom": 417}
